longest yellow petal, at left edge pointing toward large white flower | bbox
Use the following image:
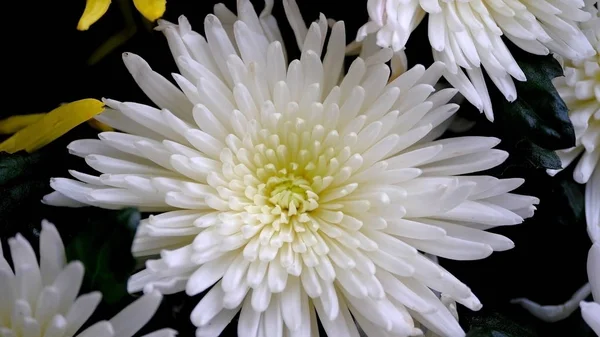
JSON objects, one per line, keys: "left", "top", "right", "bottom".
{"left": 0, "top": 98, "right": 104, "bottom": 153}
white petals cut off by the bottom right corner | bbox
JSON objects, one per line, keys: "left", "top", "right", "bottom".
{"left": 579, "top": 242, "right": 600, "bottom": 336}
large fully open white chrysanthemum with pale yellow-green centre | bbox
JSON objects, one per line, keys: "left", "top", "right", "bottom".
{"left": 45, "top": 0, "right": 538, "bottom": 337}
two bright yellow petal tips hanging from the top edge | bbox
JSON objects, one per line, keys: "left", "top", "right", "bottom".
{"left": 77, "top": 0, "right": 167, "bottom": 30}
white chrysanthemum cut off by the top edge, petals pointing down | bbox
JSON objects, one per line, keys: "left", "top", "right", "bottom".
{"left": 357, "top": 0, "right": 594, "bottom": 120}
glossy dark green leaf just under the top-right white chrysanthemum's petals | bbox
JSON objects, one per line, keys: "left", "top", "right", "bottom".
{"left": 491, "top": 51, "right": 575, "bottom": 150}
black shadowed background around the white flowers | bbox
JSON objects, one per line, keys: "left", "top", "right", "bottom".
{"left": 0, "top": 0, "right": 593, "bottom": 337}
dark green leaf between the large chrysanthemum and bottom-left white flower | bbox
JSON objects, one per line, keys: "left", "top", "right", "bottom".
{"left": 66, "top": 208, "right": 140, "bottom": 304}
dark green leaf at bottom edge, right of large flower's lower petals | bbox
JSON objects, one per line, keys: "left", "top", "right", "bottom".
{"left": 466, "top": 313, "right": 537, "bottom": 337}
